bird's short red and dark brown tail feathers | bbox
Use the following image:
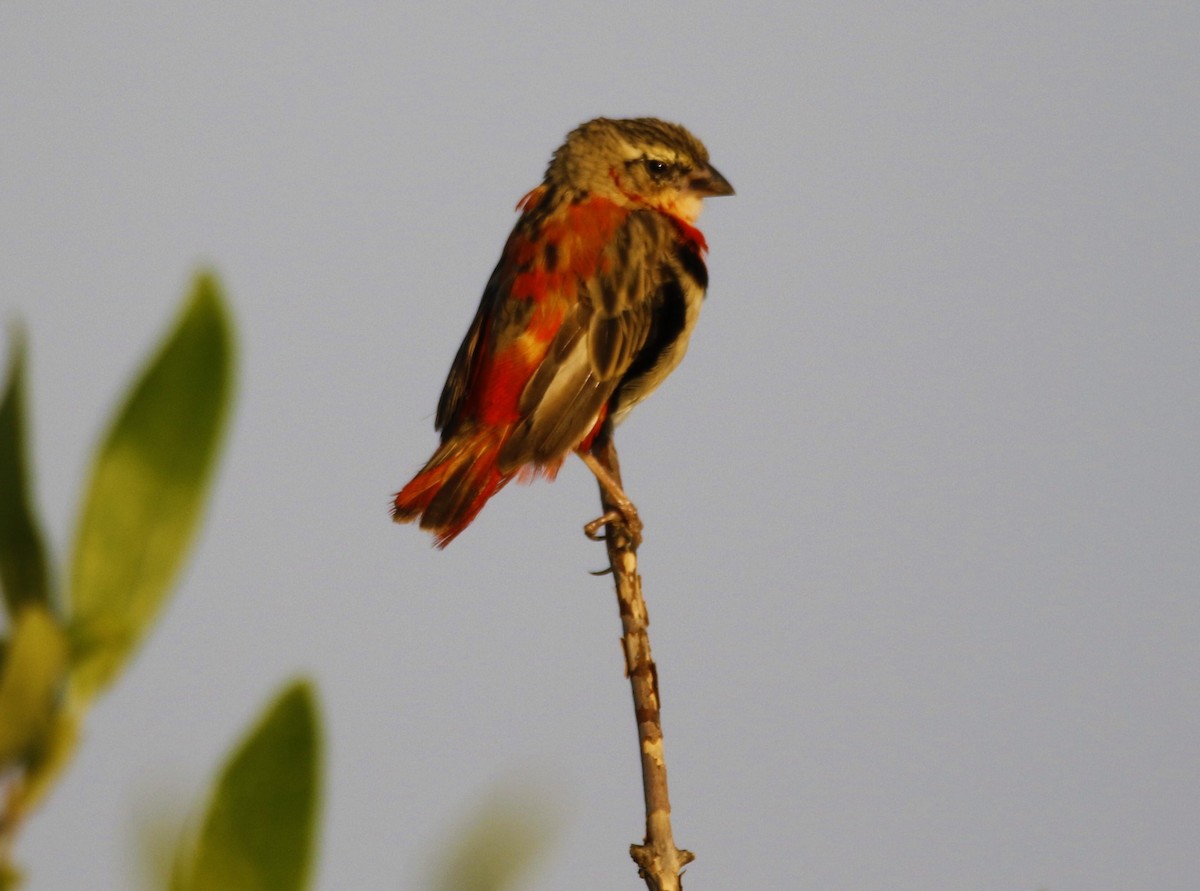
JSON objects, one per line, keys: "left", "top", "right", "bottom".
{"left": 391, "top": 427, "right": 512, "bottom": 548}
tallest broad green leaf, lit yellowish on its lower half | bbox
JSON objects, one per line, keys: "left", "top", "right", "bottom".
{"left": 71, "top": 275, "right": 233, "bottom": 700}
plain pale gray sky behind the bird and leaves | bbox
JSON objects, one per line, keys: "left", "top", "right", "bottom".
{"left": 0, "top": 2, "right": 1200, "bottom": 891}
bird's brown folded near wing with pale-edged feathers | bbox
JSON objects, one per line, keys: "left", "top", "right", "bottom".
{"left": 500, "top": 210, "right": 674, "bottom": 468}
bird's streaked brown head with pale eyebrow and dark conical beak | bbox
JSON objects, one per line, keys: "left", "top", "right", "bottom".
{"left": 546, "top": 118, "right": 733, "bottom": 223}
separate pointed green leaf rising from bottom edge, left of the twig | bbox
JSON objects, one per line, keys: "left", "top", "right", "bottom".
{"left": 172, "top": 681, "right": 320, "bottom": 891}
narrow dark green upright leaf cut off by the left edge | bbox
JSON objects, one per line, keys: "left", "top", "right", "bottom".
{"left": 0, "top": 329, "right": 49, "bottom": 618}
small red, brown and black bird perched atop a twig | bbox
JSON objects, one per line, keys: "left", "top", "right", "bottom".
{"left": 392, "top": 118, "right": 733, "bottom": 548}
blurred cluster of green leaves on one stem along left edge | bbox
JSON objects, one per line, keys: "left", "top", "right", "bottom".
{"left": 0, "top": 275, "right": 233, "bottom": 891}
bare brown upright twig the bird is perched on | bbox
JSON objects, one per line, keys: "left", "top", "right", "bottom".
{"left": 592, "top": 425, "right": 695, "bottom": 891}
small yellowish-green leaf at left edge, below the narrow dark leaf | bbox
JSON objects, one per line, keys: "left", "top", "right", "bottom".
{"left": 0, "top": 605, "right": 67, "bottom": 772}
